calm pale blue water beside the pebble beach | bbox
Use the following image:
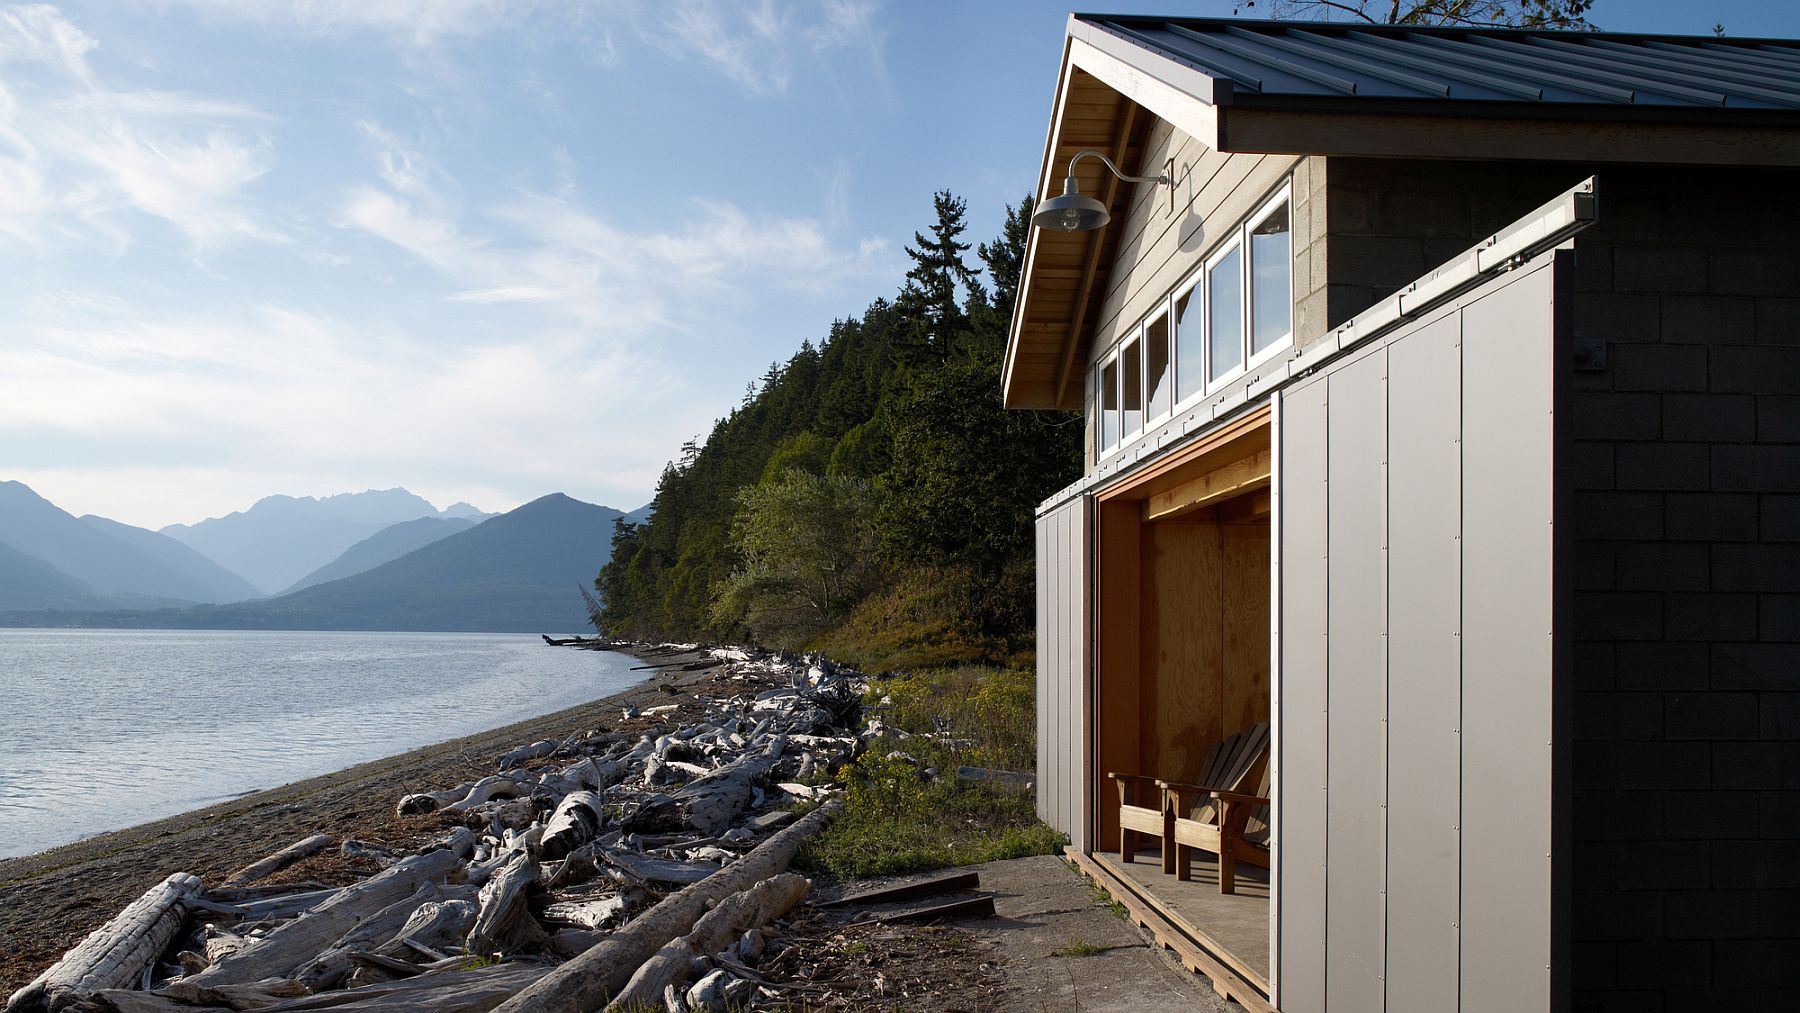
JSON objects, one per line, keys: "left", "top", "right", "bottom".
{"left": 0, "top": 630, "right": 643, "bottom": 858}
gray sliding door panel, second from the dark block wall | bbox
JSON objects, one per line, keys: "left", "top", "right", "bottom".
{"left": 1388, "top": 308, "right": 1462, "bottom": 1009}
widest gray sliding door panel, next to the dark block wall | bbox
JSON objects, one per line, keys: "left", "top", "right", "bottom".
{"left": 1462, "top": 257, "right": 1557, "bottom": 1013}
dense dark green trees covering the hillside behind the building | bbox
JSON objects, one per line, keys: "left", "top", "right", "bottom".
{"left": 594, "top": 193, "right": 1082, "bottom": 666}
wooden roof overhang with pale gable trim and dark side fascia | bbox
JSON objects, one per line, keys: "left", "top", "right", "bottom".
{"left": 1001, "top": 16, "right": 1800, "bottom": 410}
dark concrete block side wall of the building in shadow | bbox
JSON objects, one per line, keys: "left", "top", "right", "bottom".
{"left": 1327, "top": 158, "right": 1800, "bottom": 1013}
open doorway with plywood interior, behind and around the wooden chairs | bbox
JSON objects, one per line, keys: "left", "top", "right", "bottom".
{"left": 1093, "top": 412, "right": 1271, "bottom": 993}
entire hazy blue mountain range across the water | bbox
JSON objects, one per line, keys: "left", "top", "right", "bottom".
{"left": 0, "top": 482, "right": 646, "bottom": 632}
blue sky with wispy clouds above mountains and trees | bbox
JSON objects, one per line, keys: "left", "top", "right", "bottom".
{"left": 0, "top": 0, "right": 1800, "bottom": 527}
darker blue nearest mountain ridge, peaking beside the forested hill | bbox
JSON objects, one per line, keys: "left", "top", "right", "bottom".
{"left": 0, "top": 493, "right": 621, "bottom": 633}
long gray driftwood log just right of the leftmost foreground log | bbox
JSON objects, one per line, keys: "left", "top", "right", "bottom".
{"left": 187, "top": 851, "right": 461, "bottom": 984}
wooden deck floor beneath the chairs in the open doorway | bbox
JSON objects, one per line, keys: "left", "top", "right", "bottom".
{"left": 1071, "top": 849, "right": 1273, "bottom": 1011}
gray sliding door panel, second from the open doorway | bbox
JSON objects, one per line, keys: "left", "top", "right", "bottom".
{"left": 1325, "top": 347, "right": 1388, "bottom": 1013}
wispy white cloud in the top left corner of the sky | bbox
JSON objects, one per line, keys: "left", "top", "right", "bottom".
{"left": 0, "top": 5, "right": 279, "bottom": 248}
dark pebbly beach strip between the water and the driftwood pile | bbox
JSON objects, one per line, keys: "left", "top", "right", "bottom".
{"left": 0, "top": 642, "right": 716, "bottom": 995}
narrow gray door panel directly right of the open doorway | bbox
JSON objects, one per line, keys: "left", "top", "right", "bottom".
{"left": 1274, "top": 383, "right": 1327, "bottom": 1013}
